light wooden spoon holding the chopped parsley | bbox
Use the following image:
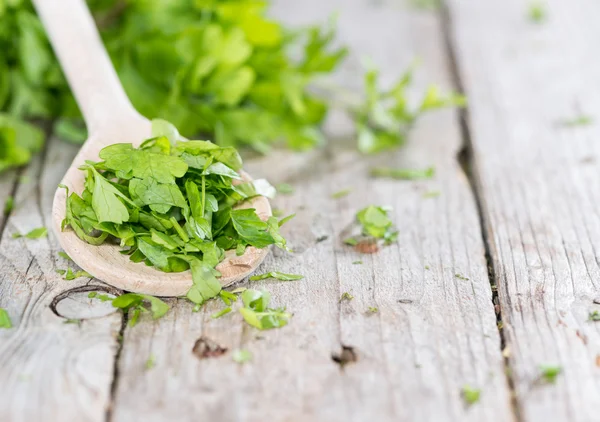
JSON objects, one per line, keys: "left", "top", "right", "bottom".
{"left": 33, "top": 0, "right": 272, "bottom": 296}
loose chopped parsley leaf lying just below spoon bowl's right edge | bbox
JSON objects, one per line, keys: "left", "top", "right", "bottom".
{"left": 240, "top": 289, "right": 292, "bottom": 330}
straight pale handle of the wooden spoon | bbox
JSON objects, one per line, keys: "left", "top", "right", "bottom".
{"left": 33, "top": 0, "right": 141, "bottom": 136}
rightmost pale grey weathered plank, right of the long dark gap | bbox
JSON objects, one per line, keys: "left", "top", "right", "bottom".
{"left": 449, "top": 0, "right": 600, "bottom": 421}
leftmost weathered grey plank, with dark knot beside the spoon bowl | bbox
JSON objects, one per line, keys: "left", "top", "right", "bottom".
{"left": 0, "top": 140, "right": 121, "bottom": 422}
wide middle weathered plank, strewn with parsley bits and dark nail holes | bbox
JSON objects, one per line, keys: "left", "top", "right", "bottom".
{"left": 112, "top": 0, "right": 512, "bottom": 422}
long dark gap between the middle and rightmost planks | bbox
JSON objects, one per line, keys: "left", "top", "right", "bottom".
{"left": 440, "top": 2, "right": 523, "bottom": 422}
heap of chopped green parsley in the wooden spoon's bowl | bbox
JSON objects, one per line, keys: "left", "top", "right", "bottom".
{"left": 62, "top": 120, "right": 289, "bottom": 304}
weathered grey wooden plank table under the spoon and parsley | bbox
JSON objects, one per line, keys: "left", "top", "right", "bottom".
{"left": 0, "top": 0, "right": 600, "bottom": 422}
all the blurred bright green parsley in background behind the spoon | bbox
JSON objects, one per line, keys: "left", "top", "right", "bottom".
{"left": 0, "top": 0, "right": 464, "bottom": 171}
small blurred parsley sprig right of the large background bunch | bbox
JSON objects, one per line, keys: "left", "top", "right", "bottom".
{"left": 353, "top": 66, "right": 466, "bottom": 154}
